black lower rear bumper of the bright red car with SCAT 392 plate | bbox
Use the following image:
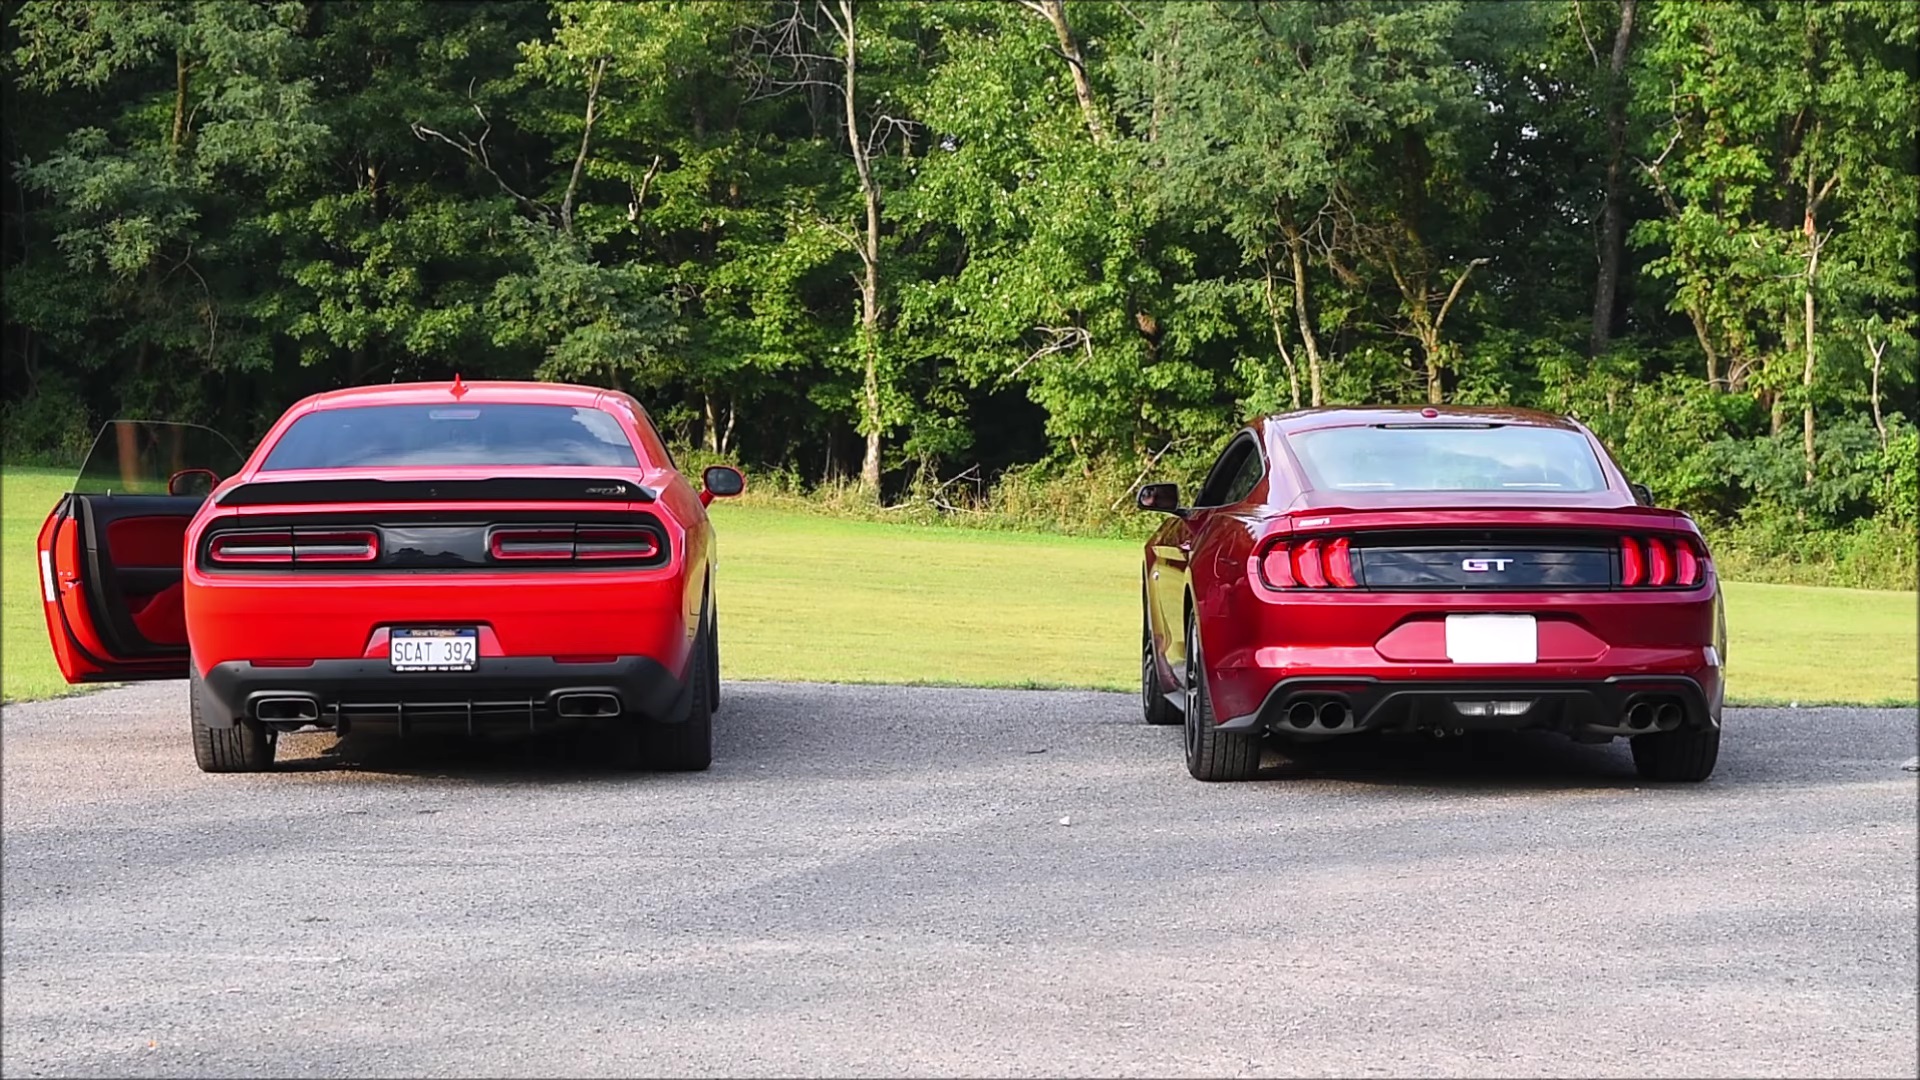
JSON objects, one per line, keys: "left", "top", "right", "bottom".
{"left": 200, "top": 655, "right": 691, "bottom": 732}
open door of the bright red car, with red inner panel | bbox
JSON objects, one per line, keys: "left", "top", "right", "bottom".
{"left": 38, "top": 421, "right": 242, "bottom": 682}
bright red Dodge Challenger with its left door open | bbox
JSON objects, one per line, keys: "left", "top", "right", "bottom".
{"left": 38, "top": 379, "right": 743, "bottom": 773}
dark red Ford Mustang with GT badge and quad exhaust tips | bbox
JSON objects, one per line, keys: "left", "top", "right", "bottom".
{"left": 1139, "top": 407, "right": 1726, "bottom": 780}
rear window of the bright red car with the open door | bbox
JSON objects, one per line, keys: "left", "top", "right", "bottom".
{"left": 261, "top": 404, "right": 639, "bottom": 471}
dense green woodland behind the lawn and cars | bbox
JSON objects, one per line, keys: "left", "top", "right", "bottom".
{"left": 0, "top": 0, "right": 1920, "bottom": 588}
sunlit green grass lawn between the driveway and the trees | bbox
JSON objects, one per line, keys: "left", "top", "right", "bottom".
{"left": 0, "top": 469, "right": 1920, "bottom": 703}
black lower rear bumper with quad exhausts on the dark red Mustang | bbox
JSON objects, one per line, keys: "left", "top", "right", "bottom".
{"left": 1219, "top": 675, "right": 1720, "bottom": 736}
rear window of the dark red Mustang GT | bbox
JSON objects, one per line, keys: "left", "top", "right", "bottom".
{"left": 1288, "top": 425, "right": 1607, "bottom": 492}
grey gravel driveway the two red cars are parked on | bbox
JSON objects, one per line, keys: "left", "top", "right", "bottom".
{"left": 0, "top": 682, "right": 1920, "bottom": 1076}
